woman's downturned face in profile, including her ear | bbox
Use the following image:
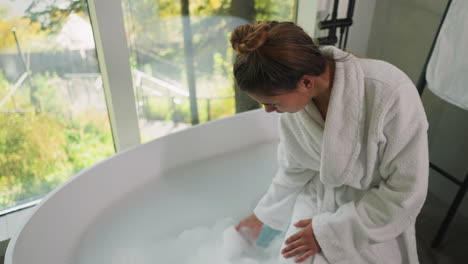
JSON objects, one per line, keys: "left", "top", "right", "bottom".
{"left": 247, "top": 76, "right": 322, "bottom": 113}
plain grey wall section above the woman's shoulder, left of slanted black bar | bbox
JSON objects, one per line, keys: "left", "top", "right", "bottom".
{"left": 367, "top": 0, "right": 447, "bottom": 83}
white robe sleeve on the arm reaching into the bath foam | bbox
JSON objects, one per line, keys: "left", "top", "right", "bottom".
{"left": 254, "top": 142, "right": 318, "bottom": 231}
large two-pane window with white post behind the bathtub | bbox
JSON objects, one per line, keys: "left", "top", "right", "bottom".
{"left": 0, "top": 0, "right": 296, "bottom": 214}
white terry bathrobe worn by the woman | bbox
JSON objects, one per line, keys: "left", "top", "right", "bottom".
{"left": 254, "top": 47, "right": 429, "bottom": 264}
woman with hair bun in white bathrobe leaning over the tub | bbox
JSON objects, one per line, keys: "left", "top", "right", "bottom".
{"left": 231, "top": 22, "right": 428, "bottom": 264}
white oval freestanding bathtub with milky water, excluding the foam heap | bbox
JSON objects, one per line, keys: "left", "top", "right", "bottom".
{"left": 5, "top": 110, "right": 278, "bottom": 264}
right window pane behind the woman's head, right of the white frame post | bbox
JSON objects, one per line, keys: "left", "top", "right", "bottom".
{"left": 123, "top": 0, "right": 296, "bottom": 142}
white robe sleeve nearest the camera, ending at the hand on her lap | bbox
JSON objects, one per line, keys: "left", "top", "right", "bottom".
{"left": 312, "top": 84, "right": 429, "bottom": 263}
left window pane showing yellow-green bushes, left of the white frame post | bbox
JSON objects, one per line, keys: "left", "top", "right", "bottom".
{"left": 0, "top": 0, "right": 114, "bottom": 211}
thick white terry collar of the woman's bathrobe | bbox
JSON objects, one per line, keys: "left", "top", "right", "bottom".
{"left": 320, "top": 46, "right": 365, "bottom": 187}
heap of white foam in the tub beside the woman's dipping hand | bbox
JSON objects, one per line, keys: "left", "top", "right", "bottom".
{"left": 151, "top": 219, "right": 282, "bottom": 264}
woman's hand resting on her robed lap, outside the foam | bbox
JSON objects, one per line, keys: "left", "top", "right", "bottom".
{"left": 281, "top": 218, "right": 321, "bottom": 263}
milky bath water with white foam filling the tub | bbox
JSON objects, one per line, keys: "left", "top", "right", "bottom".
{"left": 76, "top": 142, "right": 283, "bottom": 264}
